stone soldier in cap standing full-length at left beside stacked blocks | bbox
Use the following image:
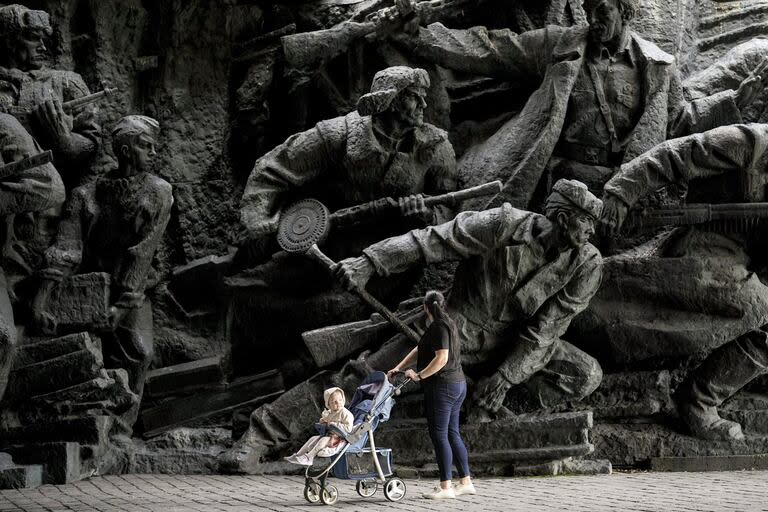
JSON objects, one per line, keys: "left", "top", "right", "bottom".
{"left": 33, "top": 115, "right": 173, "bottom": 429}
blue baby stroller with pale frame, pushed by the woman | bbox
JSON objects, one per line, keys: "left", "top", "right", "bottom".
{"left": 304, "top": 372, "right": 410, "bottom": 505}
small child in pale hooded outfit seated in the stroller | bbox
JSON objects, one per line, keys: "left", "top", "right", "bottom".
{"left": 285, "top": 388, "right": 354, "bottom": 466}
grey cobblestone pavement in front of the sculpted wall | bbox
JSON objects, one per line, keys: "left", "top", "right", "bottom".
{"left": 0, "top": 471, "right": 768, "bottom": 512}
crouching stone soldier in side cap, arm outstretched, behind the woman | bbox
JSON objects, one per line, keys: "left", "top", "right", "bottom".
{"left": 338, "top": 180, "right": 603, "bottom": 414}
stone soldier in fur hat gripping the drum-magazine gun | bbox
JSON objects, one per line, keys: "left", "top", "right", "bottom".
{"left": 241, "top": 66, "right": 456, "bottom": 293}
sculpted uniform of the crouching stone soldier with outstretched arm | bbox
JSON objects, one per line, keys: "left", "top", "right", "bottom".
{"left": 364, "top": 204, "right": 602, "bottom": 405}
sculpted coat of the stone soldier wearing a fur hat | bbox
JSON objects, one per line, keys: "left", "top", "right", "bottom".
{"left": 242, "top": 112, "right": 456, "bottom": 250}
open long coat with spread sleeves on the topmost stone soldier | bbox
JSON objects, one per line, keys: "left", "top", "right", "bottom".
{"left": 416, "top": 23, "right": 741, "bottom": 207}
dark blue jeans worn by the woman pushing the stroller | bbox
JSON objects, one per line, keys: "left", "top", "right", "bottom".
{"left": 423, "top": 379, "right": 469, "bottom": 482}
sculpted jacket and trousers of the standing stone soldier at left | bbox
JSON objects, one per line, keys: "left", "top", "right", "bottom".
{"left": 46, "top": 173, "right": 173, "bottom": 425}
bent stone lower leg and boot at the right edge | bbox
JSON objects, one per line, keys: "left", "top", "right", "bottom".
{"left": 675, "top": 330, "right": 768, "bottom": 441}
